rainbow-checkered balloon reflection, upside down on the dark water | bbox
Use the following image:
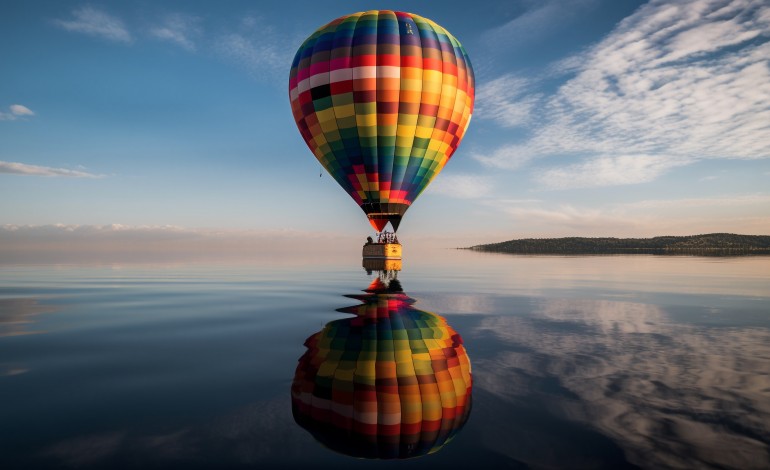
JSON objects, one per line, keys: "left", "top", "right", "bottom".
{"left": 291, "top": 272, "right": 472, "bottom": 459}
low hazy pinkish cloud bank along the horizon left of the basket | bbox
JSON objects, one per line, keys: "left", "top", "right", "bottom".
{"left": 0, "top": 224, "right": 359, "bottom": 266}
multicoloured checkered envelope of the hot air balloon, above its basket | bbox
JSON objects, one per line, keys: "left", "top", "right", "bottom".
{"left": 289, "top": 10, "right": 474, "bottom": 232}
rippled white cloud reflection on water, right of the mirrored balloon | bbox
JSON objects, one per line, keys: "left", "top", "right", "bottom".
{"left": 474, "top": 299, "right": 770, "bottom": 469}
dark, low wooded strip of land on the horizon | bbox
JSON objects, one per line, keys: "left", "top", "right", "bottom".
{"left": 461, "top": 233, "right": 770, "bottom": 256}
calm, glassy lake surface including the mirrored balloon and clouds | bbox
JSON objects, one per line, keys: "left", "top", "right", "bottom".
{"left": 0, "top": 251, "right": 770, "bottom": 469}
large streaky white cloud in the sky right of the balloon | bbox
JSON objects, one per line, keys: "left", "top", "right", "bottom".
{"left": 477, "top": 0, "right": 770, "bottom": 188}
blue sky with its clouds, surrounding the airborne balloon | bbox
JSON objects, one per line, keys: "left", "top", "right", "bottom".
{"left": 0, "top": 0, "right": 770, "bottom": 245}
